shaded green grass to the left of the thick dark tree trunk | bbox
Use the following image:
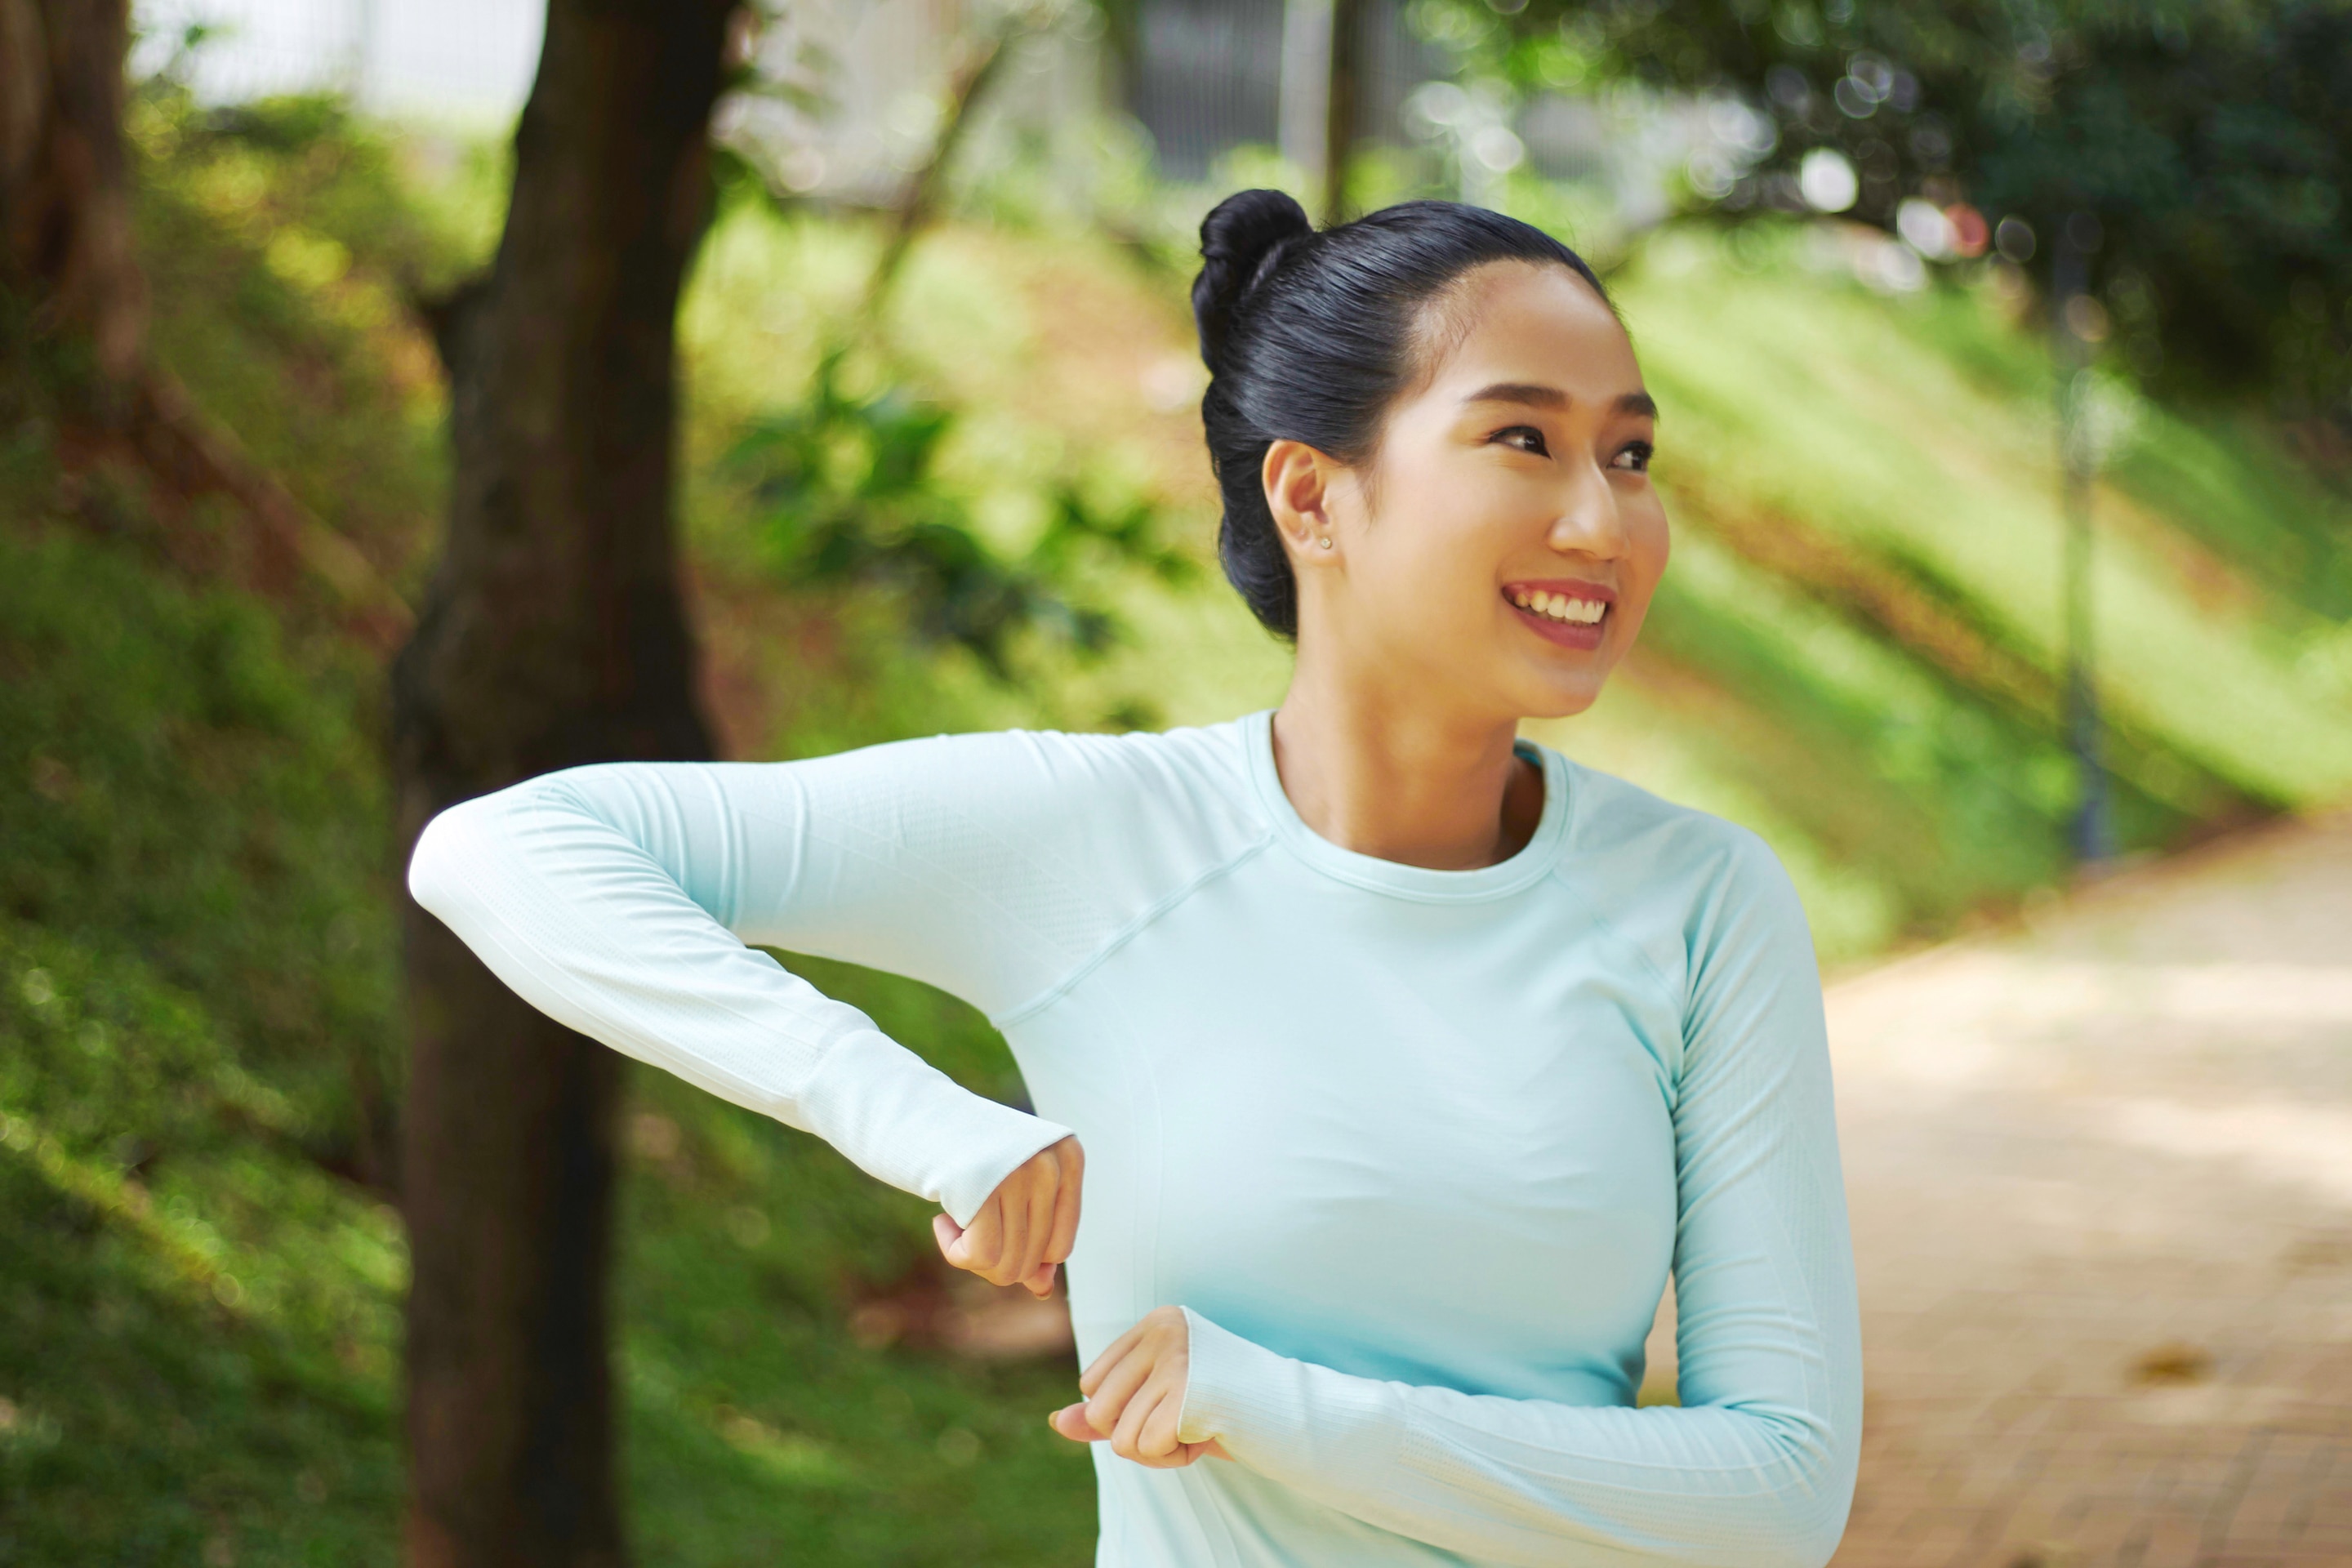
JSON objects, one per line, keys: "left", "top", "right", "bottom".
{"left": 0, "top": 512, "right": 404, "bottom": 1563}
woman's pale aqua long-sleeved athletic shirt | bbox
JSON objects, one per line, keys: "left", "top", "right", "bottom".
{"left": 409, "top": 712, "right": 1860, "bottom": 1568}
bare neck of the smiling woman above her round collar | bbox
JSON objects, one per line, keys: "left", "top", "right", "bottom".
{"left": 1275, "top": 663, "right": 1543, "bottom": 870}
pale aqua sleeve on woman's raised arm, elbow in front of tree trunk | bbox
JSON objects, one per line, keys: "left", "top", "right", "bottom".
{"left": 409, "top": 733, "right": 1147, "bottom": 1225}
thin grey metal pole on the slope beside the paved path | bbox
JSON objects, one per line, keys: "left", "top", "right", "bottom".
{"left": 2051, "top": 212, "right": 2114, "bottom": 867}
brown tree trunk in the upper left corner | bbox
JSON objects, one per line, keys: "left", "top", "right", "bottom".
{"left": 0, "top": 0, "right": 146, "bottom": 385}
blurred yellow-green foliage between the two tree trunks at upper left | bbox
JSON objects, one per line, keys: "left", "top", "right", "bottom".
{"left": 127, "top": 80, "right": 499, "bottom": 592}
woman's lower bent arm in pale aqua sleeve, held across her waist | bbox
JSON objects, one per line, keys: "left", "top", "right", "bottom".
{"left": 1054, "top": 835, "right": 1860, "bottom": 1568}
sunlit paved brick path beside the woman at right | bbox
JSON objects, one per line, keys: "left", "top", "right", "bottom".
{"left": 1787, "top": 816, "right": 2352, "bottom": 1568}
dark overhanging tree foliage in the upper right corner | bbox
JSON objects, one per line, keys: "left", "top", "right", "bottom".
{"left": 1421, "top": 0, "right": 2352, "bottom": 421}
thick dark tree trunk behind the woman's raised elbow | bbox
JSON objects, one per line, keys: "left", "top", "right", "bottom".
{"left": 393, "top": 0, "right": 729, "bottom": 1568}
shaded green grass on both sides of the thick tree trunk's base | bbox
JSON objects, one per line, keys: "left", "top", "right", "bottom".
{"left": 0, "top": 496, "right": 1094, "bottom": 1566}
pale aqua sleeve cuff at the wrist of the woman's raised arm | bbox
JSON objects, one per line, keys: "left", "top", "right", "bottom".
{"left": 797, "top": 1030, "right": 1070, "bottom": 1225}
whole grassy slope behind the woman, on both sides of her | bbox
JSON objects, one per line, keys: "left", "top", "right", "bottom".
{"left": 0, "top": 104, "right": 2352, "bottom": 1563}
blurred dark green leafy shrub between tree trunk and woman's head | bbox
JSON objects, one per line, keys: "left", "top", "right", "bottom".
{"left": 724, "top": 345, "right": 1192, "bottom": 679}
